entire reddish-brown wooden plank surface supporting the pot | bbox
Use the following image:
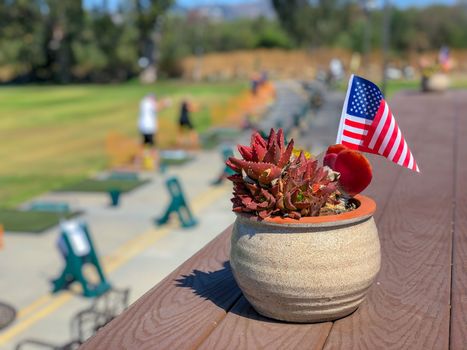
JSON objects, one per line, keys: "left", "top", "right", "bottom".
{"left": 83, "top": 92, "right": 467, "bottom": 349}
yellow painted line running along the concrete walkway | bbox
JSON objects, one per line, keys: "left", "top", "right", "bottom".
{"left": 0, "top": 186, "right": 230, "bottom": 345}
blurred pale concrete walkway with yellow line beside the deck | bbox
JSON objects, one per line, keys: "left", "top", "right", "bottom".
{"left": 0, "top": 82, "right": 335, "bottom": 349}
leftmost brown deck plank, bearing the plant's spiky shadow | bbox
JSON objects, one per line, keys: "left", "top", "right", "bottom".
{"left": 82, "top": 228, "right": 240, "bottom": 350}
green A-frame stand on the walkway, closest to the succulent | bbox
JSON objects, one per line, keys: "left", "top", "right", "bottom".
{"left": 156, "top": 177, "right": 197, "bottom": 227}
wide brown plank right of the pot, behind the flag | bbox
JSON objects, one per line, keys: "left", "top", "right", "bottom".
{"left": 325, "top": 91, "right": 453, "bottom": 349}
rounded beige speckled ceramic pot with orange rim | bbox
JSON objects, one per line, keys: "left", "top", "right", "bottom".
{"left": 230, "top": 196, "right": 381, "bottom": 322}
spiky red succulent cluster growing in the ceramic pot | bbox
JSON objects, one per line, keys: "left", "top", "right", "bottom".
{"left": 227, "top": 129, "right": 337, "bottom": 219}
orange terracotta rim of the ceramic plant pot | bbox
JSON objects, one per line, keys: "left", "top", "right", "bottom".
{"left": 235, "top": 194, "right": 376, "bottom": 227}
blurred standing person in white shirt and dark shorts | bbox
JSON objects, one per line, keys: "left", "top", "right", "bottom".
{"left": 138, "top": 94, "right": 158, "bottom": 147}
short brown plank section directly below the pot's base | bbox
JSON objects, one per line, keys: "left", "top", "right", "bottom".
{"left": 199, "top": 297, "right": 332, "bottom": 350}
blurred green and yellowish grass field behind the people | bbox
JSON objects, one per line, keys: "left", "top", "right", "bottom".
{"left": 0, "top": 81, "right": 248, "bottom": 207}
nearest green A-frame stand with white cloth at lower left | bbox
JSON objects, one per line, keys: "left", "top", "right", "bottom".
{"left": 52, "top": 224, "right": 111, "bottom": 297}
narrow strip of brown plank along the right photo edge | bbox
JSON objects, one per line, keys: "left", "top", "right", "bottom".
{"left": 450, "top": 91, "right": 467, "bottom": 350}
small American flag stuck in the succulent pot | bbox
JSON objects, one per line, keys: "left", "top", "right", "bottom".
{"left": 336, "top": 75, "right": 420, "bottom": 172}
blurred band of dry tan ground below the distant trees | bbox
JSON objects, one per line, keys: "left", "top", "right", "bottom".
{"left": 182, "top": 48, "right": 467, "bottom": 81}
